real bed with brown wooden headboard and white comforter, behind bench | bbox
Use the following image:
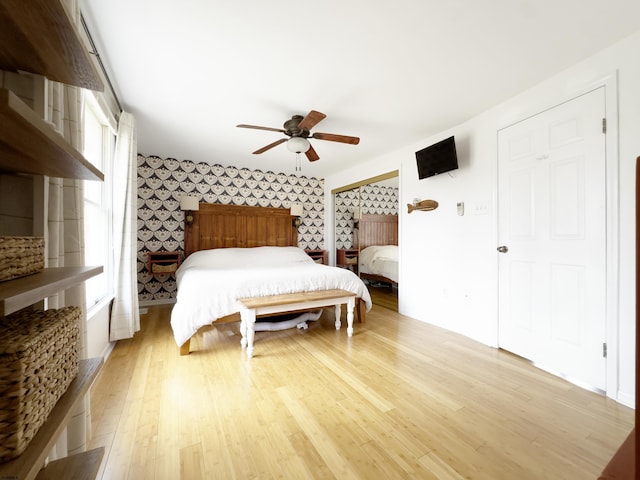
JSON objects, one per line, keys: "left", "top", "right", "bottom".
{"left": 171, "top": 204, "right": 371, "bottom": 354}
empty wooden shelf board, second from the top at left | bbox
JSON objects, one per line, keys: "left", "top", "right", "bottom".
{"left": 0, "top": 87, "right": 104, "bottom": 181}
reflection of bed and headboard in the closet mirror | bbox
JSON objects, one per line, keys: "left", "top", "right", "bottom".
{"left": 358, "top": 214, "right": 398, "bottom": 285}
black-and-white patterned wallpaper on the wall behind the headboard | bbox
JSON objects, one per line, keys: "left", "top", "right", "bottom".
{"left": 138, "top": 155, "right": 324, "bottom": 302}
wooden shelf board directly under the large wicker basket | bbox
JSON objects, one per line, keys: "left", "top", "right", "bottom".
{"left": 0, "top": 358, "right": 103, "bottom": 480}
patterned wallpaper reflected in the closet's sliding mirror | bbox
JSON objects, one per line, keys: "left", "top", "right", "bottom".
{"left": 335, "top": 185, "right": 398, "bottom": 249}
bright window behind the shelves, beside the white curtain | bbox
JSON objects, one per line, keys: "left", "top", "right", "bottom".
{"left": 83, "top": 93, "right": 115, "bottom": 310}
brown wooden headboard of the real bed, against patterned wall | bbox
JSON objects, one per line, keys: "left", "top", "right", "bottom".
{"left": 184, "top": 203, "right": 298, "bottom": 257}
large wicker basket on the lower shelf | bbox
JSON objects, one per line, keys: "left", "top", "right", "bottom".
{"left": 0, "top": 307, "right": 80, "bottom": 462}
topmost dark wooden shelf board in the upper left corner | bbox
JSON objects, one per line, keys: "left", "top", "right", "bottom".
{"left": 0, "top": 0, "right": 104, "bottom": 91}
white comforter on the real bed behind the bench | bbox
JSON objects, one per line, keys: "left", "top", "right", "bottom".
{"left": 171, "top": 247, "right": 371, "bottom": 346}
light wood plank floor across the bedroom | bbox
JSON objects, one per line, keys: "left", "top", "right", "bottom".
{"left": 91, "top": 307, "right": 633, "bottom": 480}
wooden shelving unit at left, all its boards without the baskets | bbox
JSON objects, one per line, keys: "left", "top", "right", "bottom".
{"left": 0, "top": 0, "right": 104, "bottom": 480}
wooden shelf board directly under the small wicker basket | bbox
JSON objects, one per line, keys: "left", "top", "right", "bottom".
{"left": 0, "top": 267, "right": 103, "bottom": 316}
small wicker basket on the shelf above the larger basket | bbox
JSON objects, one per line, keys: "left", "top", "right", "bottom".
{"left": 0, "top": 237, "right": 44, "bottom": 281}
